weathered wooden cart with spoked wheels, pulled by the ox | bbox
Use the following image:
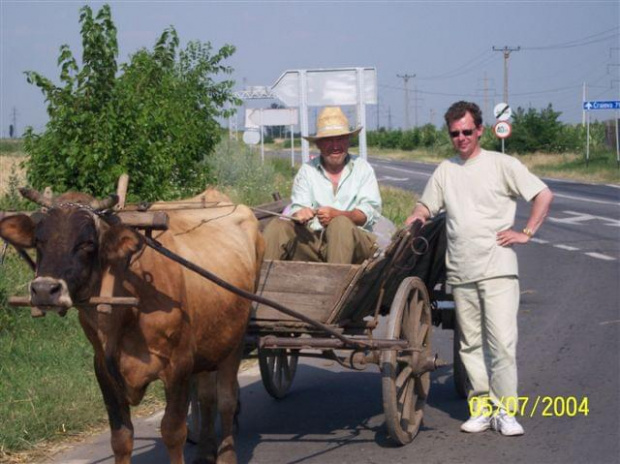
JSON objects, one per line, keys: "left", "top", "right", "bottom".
{"left": 190, "top": 203, "right": 465, "bottom": 445}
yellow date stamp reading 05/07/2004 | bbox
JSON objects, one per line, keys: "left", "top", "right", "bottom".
{"left": 467, "top": 395, "right": 590, "bottom": 417}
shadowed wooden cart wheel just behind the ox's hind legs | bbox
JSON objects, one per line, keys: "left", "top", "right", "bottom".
{"left": 258, "top": 348, "right": 299, "bottom": 400}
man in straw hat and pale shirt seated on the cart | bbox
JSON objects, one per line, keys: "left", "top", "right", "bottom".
{"left": 264, "top": 107, "right": 381, "bottom": 264}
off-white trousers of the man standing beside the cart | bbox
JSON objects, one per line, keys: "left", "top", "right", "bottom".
{"left": 452, "top": 276, "right": 519, "bottom": 407}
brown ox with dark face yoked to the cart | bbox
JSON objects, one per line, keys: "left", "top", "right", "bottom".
{"left": 0, "top": 191, "right": 263, "bottom": 464}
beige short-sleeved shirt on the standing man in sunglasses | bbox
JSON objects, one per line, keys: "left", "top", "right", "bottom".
{"left": 420, "top": 150, "right": 547, "bottom": 285}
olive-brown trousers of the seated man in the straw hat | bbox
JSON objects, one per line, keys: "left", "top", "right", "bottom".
{"left": 263, "top": 216, "right": 378, "bottom": 264}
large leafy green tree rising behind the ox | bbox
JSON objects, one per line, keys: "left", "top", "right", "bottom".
{"left": 25, "top": 5, "right": 236, "bottom": 200}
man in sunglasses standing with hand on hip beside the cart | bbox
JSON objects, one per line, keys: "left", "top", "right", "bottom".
{"left": 407, "top": 101, "right": 553, "bottom": 436}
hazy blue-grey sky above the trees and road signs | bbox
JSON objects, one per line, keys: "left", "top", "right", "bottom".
{"left": 0, "top": 0, "right": 620, "bottom": 137}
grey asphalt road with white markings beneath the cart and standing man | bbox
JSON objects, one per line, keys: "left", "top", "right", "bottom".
{"left": 43, "top": 160, "right": 620, "bottom": 464}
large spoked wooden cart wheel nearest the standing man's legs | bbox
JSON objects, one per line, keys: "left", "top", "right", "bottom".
{"left": 381, "top": 277, "right": 432, "bottom": 445}
